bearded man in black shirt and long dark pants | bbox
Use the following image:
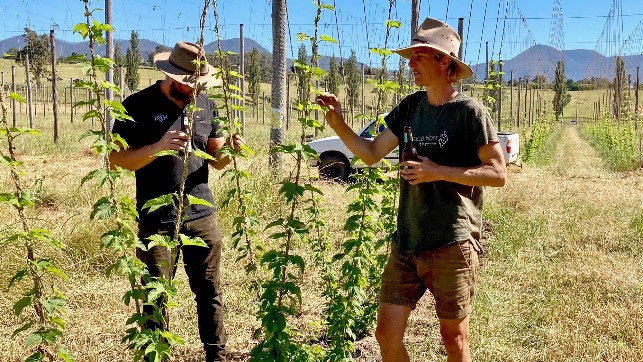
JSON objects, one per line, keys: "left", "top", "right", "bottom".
{"left": 109, "top": 42, "right": 244, "bottom": 361}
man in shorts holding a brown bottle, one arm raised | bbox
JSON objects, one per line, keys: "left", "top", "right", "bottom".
{"left": 318, "top": 18, "right": 507, "bottom": 362}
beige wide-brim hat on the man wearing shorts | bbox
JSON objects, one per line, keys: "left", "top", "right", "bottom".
{"left": 393, "top": 18, "right": 473, "bottom": 79}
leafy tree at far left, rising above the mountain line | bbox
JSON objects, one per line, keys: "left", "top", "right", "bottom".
{"left": 16, "top": 28, "right": 51, "bottom": 89}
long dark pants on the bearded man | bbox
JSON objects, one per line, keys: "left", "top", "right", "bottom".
{"left": 136, "top": 214, "right": 226, "bottom": 361}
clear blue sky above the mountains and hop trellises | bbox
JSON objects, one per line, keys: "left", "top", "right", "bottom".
{"left": 0, "top": 0, "right": 643, "bottom": 64}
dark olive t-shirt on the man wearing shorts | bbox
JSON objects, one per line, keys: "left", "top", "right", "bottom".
{"left": 385, "top": 91, "right": 498, "bottom": 253}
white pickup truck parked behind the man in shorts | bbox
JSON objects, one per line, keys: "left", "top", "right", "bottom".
{"left": 308, "top": 121, "right": 520, "bottom": 181}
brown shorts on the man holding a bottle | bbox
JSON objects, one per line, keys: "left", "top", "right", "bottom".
{"left": 379, "top": 240, "right": 481, "bottom": 319}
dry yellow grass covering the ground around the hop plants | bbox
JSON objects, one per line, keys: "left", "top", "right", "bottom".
{"left": 0, "top": 109, "right": 643, "bottom": 362}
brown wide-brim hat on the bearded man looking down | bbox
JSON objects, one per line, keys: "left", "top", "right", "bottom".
{"left": 154, "top": 41, "right": 222, "bottom": 89}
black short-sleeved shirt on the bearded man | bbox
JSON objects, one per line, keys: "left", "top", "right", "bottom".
{"left": 112, "top": 81, "right": 221, "bottom": 225}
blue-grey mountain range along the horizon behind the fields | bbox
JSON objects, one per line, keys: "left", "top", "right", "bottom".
{"left": 0, "top": 35, "right": 643, "bottom": 81}
